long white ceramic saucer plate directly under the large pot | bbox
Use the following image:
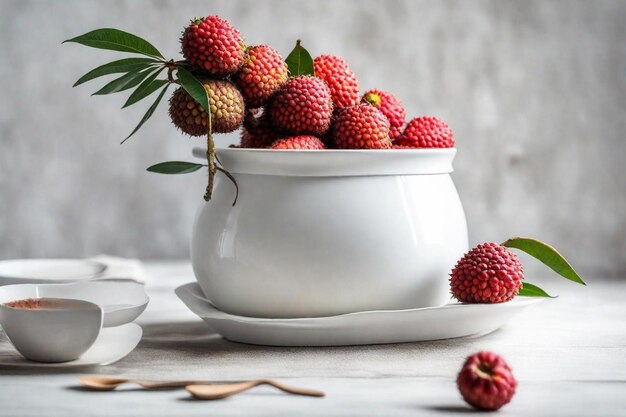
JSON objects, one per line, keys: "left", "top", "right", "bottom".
{"left": 176, "top": 282, "right": 543, "bottom": 346}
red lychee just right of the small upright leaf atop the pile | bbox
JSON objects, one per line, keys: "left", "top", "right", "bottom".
{"left": 313, "top": 55, "right": 359, "bottom": 109}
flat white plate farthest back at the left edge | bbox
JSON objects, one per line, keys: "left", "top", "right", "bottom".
{"left": 0, "top": 259, "right": 107, "bottom": 285}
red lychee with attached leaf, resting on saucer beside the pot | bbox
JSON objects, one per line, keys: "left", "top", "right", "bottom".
{"left": 450, "top": 243, "right": 524, "bottom": 303}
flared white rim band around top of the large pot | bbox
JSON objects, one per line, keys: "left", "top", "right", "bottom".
{"left": 210, "top": 148, "right": 456, "bottom": 177}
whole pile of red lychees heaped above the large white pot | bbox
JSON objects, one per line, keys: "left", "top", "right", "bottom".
{"left": 169, "top": 16, "right": 454, "bottom": 149}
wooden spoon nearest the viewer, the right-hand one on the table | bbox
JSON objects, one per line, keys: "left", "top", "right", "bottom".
{"left": 185, "top": 379, "right": 326, "bottom": 400}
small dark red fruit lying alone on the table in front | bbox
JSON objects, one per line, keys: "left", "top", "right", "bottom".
{"left": 456, "top": 352, "right": 517, "bottom": 411}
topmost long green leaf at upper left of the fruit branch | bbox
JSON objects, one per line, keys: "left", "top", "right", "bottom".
{"left": 63, "top": 28, "right": 165, "bottom": 59}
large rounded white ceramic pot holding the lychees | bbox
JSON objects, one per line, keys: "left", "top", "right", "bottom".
{"left": 191, "top": 149, "right": 467, "bottom": 317}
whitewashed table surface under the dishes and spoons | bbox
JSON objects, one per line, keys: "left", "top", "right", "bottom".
{"left": 0, "top": 262, "right": 626, "bottom": 417}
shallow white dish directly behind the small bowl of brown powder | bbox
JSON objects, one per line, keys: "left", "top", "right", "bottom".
{"left": 0, "top": 280, "right": 150, "bottom": 327}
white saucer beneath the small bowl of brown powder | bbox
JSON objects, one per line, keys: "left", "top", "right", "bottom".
{"left": 0, "top": 323, "right": 143, "bottom": 368}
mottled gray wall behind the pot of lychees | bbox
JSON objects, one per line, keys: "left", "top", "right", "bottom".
{"left": 0, "top": 0, "right": 626, "bottom": 277}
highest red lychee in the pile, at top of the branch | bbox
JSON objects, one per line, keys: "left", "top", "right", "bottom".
{"left": 181, "top": 16, "right": 244, "bottom": 77}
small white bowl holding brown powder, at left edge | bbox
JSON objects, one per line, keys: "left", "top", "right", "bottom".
{"left": 0, "top": 298, "right": 103, "bottom": 363}
